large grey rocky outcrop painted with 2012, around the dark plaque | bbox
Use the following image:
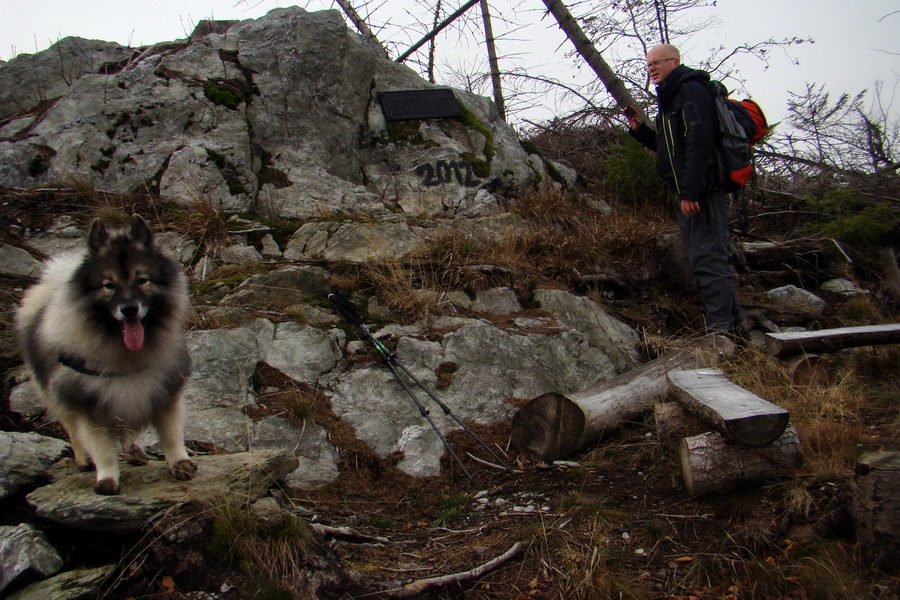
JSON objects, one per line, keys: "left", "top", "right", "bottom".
{"left": 0, "top": 7, "right": 549, "bottom": 219}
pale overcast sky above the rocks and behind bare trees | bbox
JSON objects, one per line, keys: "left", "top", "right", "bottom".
{"left": 0, "top": 0, "right": 900, "bottom": 121}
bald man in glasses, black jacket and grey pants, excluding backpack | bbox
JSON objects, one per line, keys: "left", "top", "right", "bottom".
{"left": 626, "top": 44, "right": 743, "bottom": 335}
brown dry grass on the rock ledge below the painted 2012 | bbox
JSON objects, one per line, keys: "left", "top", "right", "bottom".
{"left": 362, "top": 190, "right": 672, "bottom": 319}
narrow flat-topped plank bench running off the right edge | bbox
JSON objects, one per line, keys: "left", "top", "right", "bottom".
{"left": 766, "top": 323, "right": 900, "bottom": 358}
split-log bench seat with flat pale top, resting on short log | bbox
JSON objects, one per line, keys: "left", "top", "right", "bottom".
{"left": 668, "top": 369, "right": 790, "bottom": 446}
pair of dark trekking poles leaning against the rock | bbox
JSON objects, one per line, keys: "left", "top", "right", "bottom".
{"left": 326, "top": 289, "right": 516, "bottom": 486}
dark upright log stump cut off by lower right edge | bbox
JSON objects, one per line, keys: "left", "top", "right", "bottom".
{"left": 850, "top": 452, "right": 900, "bottom": 569}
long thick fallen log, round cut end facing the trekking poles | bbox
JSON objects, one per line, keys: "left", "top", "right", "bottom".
{"left": 511, "top": 335, "right": 735, "bottom": 462}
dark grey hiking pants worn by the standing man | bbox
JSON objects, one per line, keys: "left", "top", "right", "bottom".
{"left": 678, "top": 190, "right": 743, "bottom": 332}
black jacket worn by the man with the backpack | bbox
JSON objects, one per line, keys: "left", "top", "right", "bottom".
{"left": 629, "top": 65, "right": 718, "bottom": 201}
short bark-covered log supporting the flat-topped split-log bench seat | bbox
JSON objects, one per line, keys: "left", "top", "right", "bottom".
{"left": 679, "top": 426, "right": 800, "bottom": 496}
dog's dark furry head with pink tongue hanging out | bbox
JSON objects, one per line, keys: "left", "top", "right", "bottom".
{"left": 74, "top": 215, "right": 183, "bottom": 352}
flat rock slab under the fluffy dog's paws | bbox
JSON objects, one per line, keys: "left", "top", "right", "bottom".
{"left": 27, "top": 449, "right": 299, "bottom": 534}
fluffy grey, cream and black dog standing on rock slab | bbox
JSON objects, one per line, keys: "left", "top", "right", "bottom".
{"left": 16, "top": 215, "right": 197, "bottom": 495}
